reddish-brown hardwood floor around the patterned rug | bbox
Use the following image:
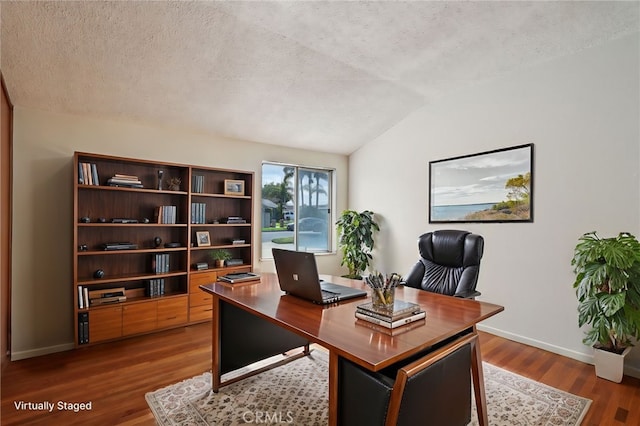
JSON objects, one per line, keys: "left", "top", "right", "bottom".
{"left": 0, "top": 323, "right": 640, "bottom": 426}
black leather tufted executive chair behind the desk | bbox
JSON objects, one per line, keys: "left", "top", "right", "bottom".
{"left": 405, "top": 229, "right": 484, "bottom": 299}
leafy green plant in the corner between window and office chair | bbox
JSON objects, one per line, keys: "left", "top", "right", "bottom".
{"left": 336, "top": 210, "right": 380, "bottom": 279}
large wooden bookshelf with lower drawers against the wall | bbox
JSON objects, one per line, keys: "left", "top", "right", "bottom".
{"left": 73, "top": 152, "right": 254, "bottom": 346}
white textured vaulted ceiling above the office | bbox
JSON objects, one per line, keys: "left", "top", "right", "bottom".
{"left": 0, "top": 1, "right": 639, "bottom": 154}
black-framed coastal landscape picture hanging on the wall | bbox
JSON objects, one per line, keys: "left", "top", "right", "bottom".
{"left": 429, "top": 144, "right": 533, "bottom": 223}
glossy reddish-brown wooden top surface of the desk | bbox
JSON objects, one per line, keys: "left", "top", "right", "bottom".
{"left": 200, "top": 273, "right": 504, "bottom": 371}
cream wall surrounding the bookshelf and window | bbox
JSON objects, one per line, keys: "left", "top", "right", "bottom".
{"left": 11, "top": 108, "right": 348, "bottom": 360}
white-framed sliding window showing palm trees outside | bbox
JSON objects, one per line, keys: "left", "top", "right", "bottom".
{"left": 261, "top": 163, "right": 333, "bottom": 259}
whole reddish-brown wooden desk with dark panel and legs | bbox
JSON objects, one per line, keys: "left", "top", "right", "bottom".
{"left": 201, "top": 273, "right": 504, "bottom": 426}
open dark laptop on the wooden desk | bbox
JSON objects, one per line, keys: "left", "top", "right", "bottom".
{"left": 271, "top": 248, "right": 367, "bottom": 305}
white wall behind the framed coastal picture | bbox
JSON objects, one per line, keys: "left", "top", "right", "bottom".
{"left": 349, "top": 34, "right": 640, "bottom": 375}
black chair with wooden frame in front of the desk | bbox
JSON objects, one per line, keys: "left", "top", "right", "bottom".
{"left": 338, "top": 333, "right": 477, "bottom": 426}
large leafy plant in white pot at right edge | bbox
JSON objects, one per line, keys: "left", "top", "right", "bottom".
{"left": 571, "top": 232, "right": 640, "bottom": 383}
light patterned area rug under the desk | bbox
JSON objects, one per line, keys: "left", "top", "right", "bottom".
{"left": 145, "top": 350, "right": 591, "bottom": 426}
